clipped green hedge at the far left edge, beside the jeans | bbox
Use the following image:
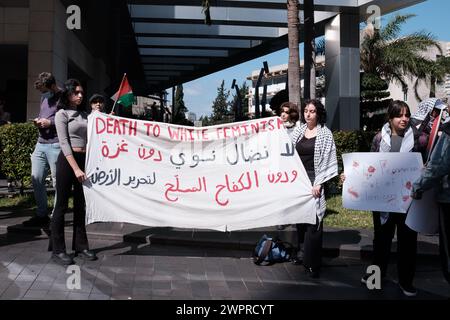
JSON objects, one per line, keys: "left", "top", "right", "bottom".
{"left": 0, "top": 123, "right": 38, "bottom": 191}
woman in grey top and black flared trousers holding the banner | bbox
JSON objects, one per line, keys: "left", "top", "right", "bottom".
{"left": 51, "top": 79, "right": 97, "bottom": 265}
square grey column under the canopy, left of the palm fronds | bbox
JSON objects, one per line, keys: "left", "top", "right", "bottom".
{"left": 325, "top": 13, "right": 360, "bottom": 130}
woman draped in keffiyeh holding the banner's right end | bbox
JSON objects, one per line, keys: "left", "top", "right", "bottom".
{"left": 291, "top": 99, "right": 338, "bottom": 278}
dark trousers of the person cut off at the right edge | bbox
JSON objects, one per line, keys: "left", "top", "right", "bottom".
{"left": 439, "top": 203, "right": 450, "bottom": 283}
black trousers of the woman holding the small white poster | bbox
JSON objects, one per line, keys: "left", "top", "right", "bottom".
{"left": 373, "top": 212, "right": 417, "bottom": 286}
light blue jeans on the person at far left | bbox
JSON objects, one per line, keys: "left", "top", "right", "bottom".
{"left": 31, "top": 142, "right": 61, "bottom": 217}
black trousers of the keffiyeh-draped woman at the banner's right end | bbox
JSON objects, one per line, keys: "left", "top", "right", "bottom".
{"left": 296, "top": 217, "right": 323, "bottom": 270}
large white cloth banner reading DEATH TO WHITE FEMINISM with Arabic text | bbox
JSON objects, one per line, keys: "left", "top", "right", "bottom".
{"left": 84, "top": 112, "right": 316, "bottom": 231}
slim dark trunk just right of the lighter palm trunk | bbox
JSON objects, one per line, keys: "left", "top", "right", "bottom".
{"left": 303, "top": 0, "right": 316, "bottom": 99}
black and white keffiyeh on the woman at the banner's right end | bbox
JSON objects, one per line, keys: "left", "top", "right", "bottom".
{"left": 291, "top": 124, "right": 338, "bottom": 220}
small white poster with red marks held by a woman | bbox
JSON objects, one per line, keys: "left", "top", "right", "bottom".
{"left": 342, "top": 152, "right": 423, "bottom": 213}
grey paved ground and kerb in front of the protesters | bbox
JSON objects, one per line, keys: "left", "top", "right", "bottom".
{"left": 0, "top": 208, "right": 450, "bottom": 300}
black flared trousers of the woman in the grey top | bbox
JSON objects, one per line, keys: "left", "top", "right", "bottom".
{"left": 51, "top": 152, "right": 89, "bottom": 254}
